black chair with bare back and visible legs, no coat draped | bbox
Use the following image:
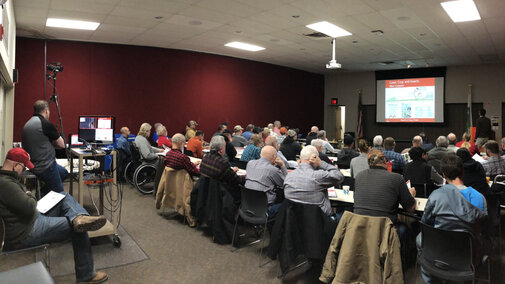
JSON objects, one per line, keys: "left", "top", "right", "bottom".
{"left": 231, "top": 186, "right": 268, "bottom": 267}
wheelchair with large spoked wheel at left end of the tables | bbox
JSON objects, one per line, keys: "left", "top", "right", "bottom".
{"left": 124, "top": 142, "right": 156, "bottom": 194}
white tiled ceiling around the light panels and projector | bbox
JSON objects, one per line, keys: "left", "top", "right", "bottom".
{"left": 11, "top": 0, "right": 505, "bottom": 73}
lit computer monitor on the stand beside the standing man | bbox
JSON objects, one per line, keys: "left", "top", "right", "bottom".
{"left": 78, "top": 115, "right": 115, "bottom": 144}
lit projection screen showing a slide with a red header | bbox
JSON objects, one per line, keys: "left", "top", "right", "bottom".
{"left": 377, "top": 77, "right": 444, "bottom": 123}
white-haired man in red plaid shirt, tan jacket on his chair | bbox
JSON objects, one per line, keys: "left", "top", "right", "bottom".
{"left": 165, "top": 133, "right": 200, "bottom": 176}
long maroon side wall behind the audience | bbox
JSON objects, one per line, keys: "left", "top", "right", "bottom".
{"left": 14, "top": 38, "right": 324, "bottom": 141}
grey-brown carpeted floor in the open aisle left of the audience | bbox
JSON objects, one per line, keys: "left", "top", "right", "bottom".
{"left": 0, "top": 181, "right": 503, "bottom": 283}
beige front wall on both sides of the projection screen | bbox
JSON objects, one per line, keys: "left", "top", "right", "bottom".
{"left": 324, "top": 64, "right": 505, "bottom": 139}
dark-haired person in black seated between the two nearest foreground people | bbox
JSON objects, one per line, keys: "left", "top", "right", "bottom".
{"left": 403, "top": 147, "right": 444, "bottom": 190}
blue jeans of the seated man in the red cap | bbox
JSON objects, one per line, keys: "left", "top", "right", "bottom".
{"left": 21, "top": 192, "right": 95, "bottom": 281}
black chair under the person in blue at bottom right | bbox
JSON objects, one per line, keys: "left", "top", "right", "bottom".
{"left": 415, "top": 223, "right": 491, "bottom": 282}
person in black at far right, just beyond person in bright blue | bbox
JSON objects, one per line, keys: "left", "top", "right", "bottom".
{"left": 456, "top": 148, "right": 489, "bottom": 194}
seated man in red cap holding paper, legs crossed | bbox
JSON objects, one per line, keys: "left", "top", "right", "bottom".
{"left": 0, "top": 148, "right": 108, "bottom": 283}
